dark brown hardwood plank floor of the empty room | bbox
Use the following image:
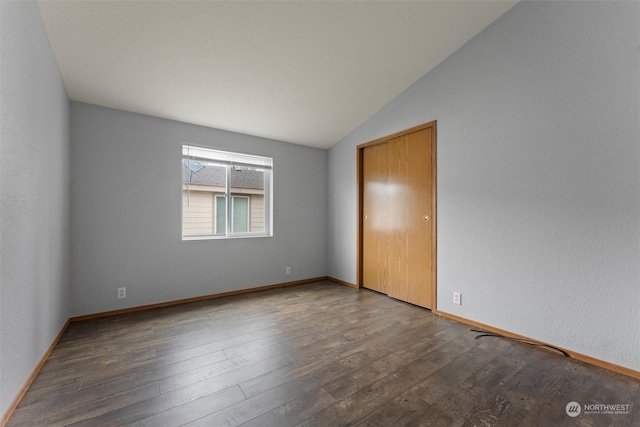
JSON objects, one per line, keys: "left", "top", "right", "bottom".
{"left": 8, "top": 282, "right": 640, "bottom": 427}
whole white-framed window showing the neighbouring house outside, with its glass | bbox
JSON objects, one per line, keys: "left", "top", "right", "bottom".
{"left": 182, "top": 144, "right": 273, "bottom": 240}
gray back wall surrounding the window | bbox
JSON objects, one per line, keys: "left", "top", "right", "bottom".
{"left": 71, "top": 102, "right": 327, "bottom": 315}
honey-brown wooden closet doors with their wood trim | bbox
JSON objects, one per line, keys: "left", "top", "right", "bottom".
{"left": 358, "top": 122, "right": 435, "bottom": 308}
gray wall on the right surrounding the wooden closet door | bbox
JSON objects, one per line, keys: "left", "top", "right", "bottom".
{"left": 328, "top": 2, "right": 640, "bottom": 370}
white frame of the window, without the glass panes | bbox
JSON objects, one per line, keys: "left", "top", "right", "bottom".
{"left": 180, "top": 143, "right": 273, "bottom": 240}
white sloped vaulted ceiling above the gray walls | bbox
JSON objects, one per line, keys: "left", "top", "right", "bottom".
{"left": 39, "top": 0, "right": 515, "bottom": 148}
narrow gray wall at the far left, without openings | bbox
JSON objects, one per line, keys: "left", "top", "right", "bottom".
{"left": 0, "top": 1, "right": 69, "bottom": 415}
